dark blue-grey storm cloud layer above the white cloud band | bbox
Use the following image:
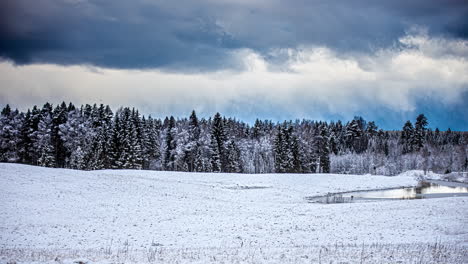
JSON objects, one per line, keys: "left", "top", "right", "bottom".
{"left": 0, "top": 0, "right": 468, "bottom": 70}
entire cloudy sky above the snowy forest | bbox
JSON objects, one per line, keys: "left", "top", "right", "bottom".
{"left": 0, "top": 0, "right": 468, "bottom": 131}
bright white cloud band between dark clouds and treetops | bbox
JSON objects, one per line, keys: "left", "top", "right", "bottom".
{"left": 0, "top": 31, "right": 468, "bottom": 118}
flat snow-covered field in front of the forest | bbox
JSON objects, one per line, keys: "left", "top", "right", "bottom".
{"left": 0, "top": 163, "right": 468, "bottom": 263}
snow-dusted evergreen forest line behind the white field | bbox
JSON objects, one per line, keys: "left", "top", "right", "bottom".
{"left": 0, "top": 102, "right": 468, "bottom": 175}
